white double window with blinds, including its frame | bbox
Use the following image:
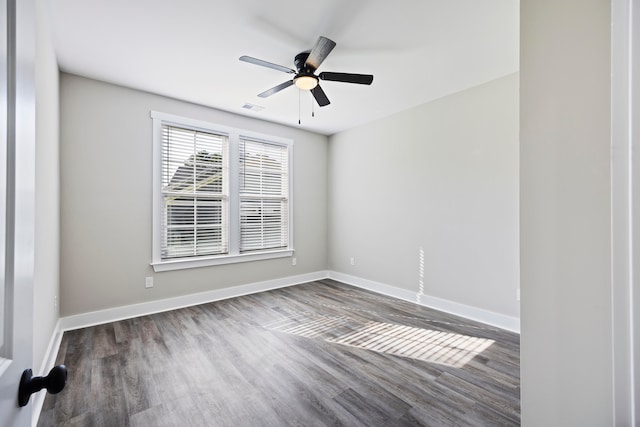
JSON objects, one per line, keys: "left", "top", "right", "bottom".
{"left": 151, "top": 112, "right": 293, "bottom": 271}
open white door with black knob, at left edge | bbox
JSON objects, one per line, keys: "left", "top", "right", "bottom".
{"left": 0, "top": 0, "right": 35, "bottom": 427}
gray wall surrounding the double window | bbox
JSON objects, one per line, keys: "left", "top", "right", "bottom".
{"left": 60, "top": 73, "right": 328, "bottom": 316}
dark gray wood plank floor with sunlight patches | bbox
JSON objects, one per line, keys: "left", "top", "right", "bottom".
{"left": 38, "top": 280, "right": 520, "bottom": 427}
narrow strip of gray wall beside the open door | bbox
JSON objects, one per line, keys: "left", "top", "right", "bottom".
{"left": 33, "top": 1, "right": 60, "bottom": 374}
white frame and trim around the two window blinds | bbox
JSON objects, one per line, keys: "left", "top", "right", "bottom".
{"left": 150, "top": 111, "right": 294, "bottom": 272}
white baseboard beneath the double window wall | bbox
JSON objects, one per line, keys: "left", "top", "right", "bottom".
{"left": 60, "top": 271, "right": 328, "bottom": 331}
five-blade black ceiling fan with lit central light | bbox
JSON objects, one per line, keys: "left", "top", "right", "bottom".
{"left": 240, "top": 36, "right": 373, "bottom": 107}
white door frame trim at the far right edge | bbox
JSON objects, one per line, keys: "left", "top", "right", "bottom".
{"left": 611, "top": 0, "right": 640, "bottom": 425}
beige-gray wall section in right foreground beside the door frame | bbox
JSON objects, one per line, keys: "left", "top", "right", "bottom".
{"left": 520, "top": 0, "right": 613, "bottom": 426}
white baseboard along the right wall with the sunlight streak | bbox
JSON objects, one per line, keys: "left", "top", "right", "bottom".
{"left": 329, "top": 271, "right": 520, "bottom": 333}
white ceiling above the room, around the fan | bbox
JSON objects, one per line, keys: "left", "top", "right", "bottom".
{"left": 47, "top": 0, "right": 519, "bottom": 135}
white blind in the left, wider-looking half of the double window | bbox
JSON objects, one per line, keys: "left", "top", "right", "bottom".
{"left": 161, "top": 124, "right": 229, "bottom": 260}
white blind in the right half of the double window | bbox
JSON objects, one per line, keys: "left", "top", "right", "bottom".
{"left": 239, "top": 139, "right": 289, "bottom": 253}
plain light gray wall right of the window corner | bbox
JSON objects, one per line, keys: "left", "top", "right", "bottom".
{"left": 329, "top": 74, "right": 519, "bottom": 318}
